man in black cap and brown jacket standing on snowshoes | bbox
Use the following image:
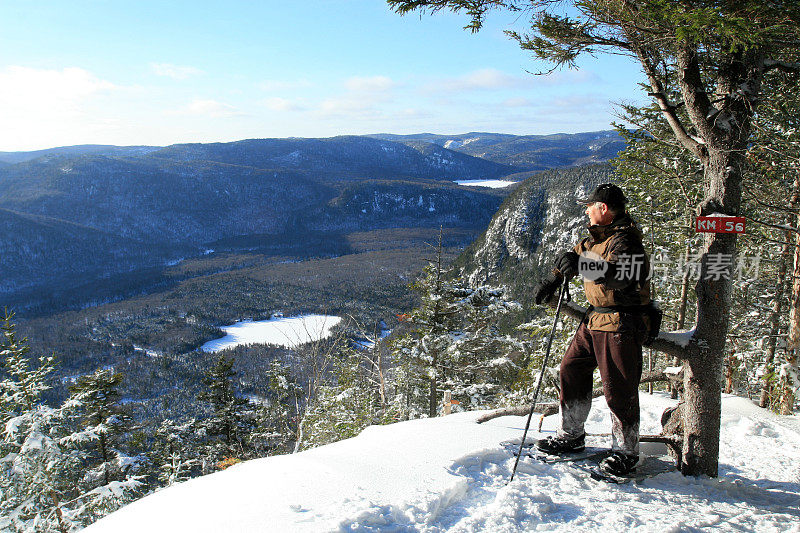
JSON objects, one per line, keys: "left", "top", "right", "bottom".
{"left": 534, "top": 183, "right": 651, "bottom": 475}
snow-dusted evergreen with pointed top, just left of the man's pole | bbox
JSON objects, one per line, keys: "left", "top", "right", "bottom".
{"left": 391, "top": 250, "right": 525, "bottom": 419}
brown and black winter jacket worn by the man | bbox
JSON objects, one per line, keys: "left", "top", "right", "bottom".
{"left": 574, "top": 213, "right": 650, "bottom": 333}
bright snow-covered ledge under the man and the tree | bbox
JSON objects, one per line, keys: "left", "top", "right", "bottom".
{"left": 87, "top": 393, "right": 800, "bottom": 533}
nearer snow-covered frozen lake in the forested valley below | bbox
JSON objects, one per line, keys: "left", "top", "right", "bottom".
{"left": 200, "top": 315, "right": 342, "bottom": 353}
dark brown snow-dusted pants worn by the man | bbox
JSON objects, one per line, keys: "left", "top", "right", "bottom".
{"left": 559, "top": 321, "right": 644, "bottom": 454}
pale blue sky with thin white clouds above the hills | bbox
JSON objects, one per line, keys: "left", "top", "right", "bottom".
{"left": 0, "top": 0, "right": 642, "bottom": 151}
